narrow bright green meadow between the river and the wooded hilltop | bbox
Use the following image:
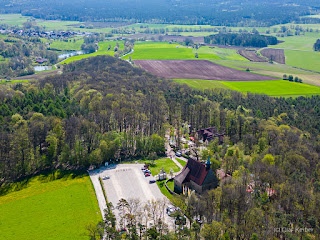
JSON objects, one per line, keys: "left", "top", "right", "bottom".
{"left": 61, "top": 41, "right": 124, "bottom": 64}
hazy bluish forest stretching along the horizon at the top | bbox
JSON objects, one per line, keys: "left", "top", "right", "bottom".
{"left": 0, "top": 0, "right": 319, "bottom": 26}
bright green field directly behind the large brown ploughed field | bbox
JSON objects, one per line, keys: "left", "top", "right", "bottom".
{"left": 124, "top": 42, "right": 220, "bottom": 60}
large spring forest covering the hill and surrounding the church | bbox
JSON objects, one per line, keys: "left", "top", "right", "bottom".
{"left": 0, "top": 56, "right": 320, "bottom": 240}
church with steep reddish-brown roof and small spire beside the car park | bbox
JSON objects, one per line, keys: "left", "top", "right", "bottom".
{"left": 174, "top": 158, "right": 218, "bottom": 194}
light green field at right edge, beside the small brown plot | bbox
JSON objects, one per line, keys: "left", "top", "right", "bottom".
{"left": 285, "top": 50, "right": 320, "bottom": 72}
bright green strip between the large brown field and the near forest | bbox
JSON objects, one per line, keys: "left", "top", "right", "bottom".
{"left": 175, "top": 79, "right": 320, "bottom": 96}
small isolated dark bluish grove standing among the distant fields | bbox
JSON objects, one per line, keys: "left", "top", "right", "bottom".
{"left": 204, "top": 33, "right": 278, "bottom": 48}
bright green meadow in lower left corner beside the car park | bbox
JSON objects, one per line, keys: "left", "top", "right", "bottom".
{"left": 0, "top": 175, "right": 102, "bottom": 240}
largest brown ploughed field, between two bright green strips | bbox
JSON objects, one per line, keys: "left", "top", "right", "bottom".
{"left": 134, "top": 60, "right": 276, "bottom": 81}
